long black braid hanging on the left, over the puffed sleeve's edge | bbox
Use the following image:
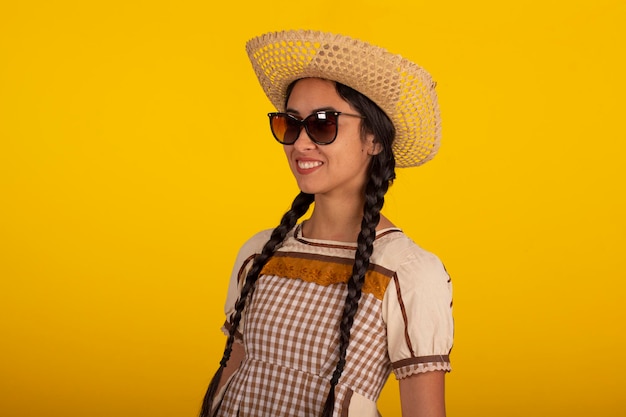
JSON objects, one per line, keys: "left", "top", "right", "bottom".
{"left": 200, "top": 192, "right": 314, "bottom": 417}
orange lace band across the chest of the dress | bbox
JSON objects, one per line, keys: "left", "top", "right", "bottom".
{"left": 261, "top": 252, "right": 393, "bottom": 300}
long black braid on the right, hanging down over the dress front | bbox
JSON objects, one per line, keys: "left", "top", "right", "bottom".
{"left": 322, "top": 158, "right": 395, "bottom": 417}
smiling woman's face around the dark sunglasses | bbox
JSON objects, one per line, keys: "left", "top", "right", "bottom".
{"left": 283, "top": 78, "right": 378, "bottom": 198}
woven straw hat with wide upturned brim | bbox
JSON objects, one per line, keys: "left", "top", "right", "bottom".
{"left": 246, "top": 30, "right": 441, "bottom": 167}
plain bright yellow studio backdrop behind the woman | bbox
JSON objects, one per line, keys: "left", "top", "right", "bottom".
{"left": 0, "top": 0, "right": 626, "bottom": 417}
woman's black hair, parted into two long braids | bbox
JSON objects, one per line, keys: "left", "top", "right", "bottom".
{"left": 200, "top": 81, "right": 395, "bottom": 417}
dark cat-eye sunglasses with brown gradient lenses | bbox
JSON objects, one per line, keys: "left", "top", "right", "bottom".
{"left": 268, "top": 111, "right": 365, "bottom": 145}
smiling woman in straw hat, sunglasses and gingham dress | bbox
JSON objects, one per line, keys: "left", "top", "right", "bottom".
{"left": 201, "top": 31, "right": 453, "bottom": 417}
